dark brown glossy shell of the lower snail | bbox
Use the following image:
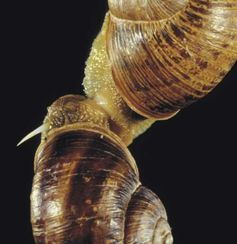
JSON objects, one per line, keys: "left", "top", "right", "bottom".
{"left": 31, "top": 123, "right": 173, "bottom": 244}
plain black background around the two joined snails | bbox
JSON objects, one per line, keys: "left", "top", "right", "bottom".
{"left": 1, "top": 0, "right": 237, "bottom": 244}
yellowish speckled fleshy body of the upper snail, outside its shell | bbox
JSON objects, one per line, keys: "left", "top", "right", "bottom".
{"left": 83, "top": 14, "right": 155, "bottom": 145}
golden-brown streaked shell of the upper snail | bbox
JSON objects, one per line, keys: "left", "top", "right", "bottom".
{"left": 107, "top": 0, "right": 237, "bottom": 119}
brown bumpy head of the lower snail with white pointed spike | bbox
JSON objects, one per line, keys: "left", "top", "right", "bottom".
{"left": 17, "top": 95, "right": 109, "bottom": 146}
